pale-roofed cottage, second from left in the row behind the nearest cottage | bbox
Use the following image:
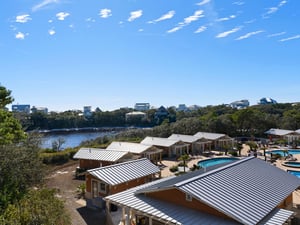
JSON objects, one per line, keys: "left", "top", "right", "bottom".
{"left": 106, "top": 141, "right": 162, "bottom": 164}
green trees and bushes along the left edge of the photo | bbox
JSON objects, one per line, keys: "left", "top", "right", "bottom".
{"left": 0, "top": 86, "right": 70, "bottom": 225}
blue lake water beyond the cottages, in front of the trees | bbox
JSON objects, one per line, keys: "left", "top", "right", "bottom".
{"left": 41, "top": 131, "right": 117, "bottom": 149}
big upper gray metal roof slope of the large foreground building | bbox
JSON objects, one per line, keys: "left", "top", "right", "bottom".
{"left": 175, "top": 157, "right": 300, "bottom": 224}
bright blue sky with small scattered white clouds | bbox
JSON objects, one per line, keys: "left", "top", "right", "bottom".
{"left": 0, "top": 0, "right": 300, "bottom": 111}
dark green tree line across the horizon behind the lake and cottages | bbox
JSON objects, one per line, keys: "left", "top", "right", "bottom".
{"left": 15, "top": 99, "right": 300, "bottom": 137}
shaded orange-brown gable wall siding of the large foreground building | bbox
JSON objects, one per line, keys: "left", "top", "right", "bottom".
{"left": 147, "top": 189, "right": 232, "bottom": 220}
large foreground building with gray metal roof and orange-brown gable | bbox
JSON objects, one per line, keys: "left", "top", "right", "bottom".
{"left": 104, "top": 157, "right": 300, "bottom": 225}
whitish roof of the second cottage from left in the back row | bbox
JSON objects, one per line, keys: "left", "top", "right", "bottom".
{"left": 106, "top": 141, "right": 155, "bottom": 154}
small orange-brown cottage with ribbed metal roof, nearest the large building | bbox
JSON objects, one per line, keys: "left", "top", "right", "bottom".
{"left": 85, "top": 158, "right": 160, "bottom": 207}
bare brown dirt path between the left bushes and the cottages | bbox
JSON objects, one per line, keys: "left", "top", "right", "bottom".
{"left": 46, "top": 161, "right": 105, "bottom": 225}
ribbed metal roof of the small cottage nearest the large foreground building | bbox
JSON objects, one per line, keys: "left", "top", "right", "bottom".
{"left": 87, "top": 158, "right": 160, "bottom": 185}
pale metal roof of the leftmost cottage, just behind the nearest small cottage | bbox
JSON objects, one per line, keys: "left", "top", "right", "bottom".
{"left": 73, "top": 148, "right": 128, "bottom": 162}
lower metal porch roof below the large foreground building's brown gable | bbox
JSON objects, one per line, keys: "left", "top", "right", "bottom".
{"left": 104, "top": 177, "right": 240, "bottom": 225}
